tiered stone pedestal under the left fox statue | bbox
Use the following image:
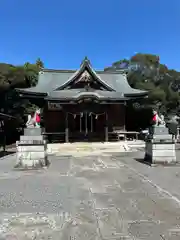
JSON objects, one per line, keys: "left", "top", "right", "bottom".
{"left": 15, "top": 128, "right": 49, "bottom": 169}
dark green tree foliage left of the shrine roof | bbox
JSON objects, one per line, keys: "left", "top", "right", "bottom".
{"left": 0, "top": 58, "right": 44, "bottom": 123}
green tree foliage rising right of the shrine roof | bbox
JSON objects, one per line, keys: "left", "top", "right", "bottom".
{"left": 105, "top": 53, "right": 180, "bottom": 115}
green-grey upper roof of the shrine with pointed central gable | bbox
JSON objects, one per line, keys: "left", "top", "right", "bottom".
{"left": 17, "top": 58, "right": 147, "bottom": 98}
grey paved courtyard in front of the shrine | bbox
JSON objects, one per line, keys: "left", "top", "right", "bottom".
{"left": 0, "top": 152, "right": 180, "bottom": 240}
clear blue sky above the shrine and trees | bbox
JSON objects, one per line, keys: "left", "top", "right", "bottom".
{"left": 0, "top": 0, "right": 180, "bottom": 70}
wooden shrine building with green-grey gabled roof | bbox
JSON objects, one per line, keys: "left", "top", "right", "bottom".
{"left": 17, "top": 58, "right": 147, "bottom": 142}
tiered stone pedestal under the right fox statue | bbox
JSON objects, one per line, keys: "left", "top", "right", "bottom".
{"left": 144, "top": 126, "right": 177, "bottom": 165}
